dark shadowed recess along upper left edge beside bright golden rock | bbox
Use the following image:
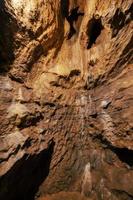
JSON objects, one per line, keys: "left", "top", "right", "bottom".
{"left": 0, "top": 0, "right": 18, "bottom": 73}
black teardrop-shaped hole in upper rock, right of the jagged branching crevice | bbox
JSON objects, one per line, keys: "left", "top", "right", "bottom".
{"left": 88, "top": 17, "right": 104, "bottom": 49}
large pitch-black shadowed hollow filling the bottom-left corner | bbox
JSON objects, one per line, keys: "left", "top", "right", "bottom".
{"left": 0, "top": 141, "right": 55, "bottom": 200}
